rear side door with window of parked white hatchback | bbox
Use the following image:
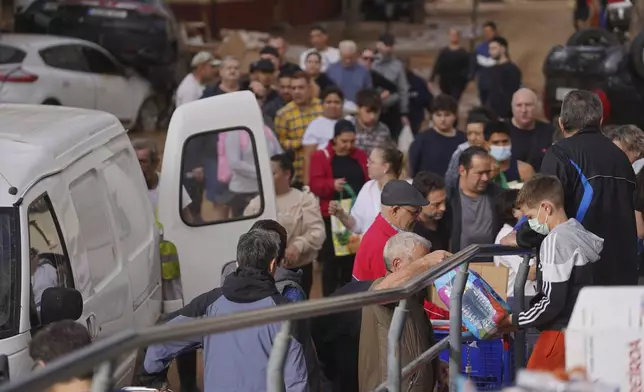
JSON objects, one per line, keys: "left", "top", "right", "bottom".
{"left": 39, "top": 45, "right": 96, "bottom": 109}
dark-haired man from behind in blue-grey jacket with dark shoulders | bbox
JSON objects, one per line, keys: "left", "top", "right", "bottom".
{"left": 143, "top": 229, "right": 320, "bottom": 392}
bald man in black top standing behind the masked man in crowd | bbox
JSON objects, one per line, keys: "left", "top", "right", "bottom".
{"left": 510, "top": 87, "right": 554, "bottom": 171}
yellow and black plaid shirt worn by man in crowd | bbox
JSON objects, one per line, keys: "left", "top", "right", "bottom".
{"left": 275, "top": 98, "right": 322, "bottom": 180}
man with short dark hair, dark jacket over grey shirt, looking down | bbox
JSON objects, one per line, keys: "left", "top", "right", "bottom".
{"left": 449, "top": 146, "right": 501, "bottom": 253}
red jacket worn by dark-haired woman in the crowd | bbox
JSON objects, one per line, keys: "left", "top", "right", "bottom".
{"left": 309, "top": 142, "right": 369, "bottom": 218}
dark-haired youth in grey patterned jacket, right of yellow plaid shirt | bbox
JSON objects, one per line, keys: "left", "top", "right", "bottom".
{"left": 355, "top": 89, "right": 391, "bottom": 155}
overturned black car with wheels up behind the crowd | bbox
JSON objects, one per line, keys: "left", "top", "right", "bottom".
{"left": 543, "top": 29, "right": 644, "bottom": 129}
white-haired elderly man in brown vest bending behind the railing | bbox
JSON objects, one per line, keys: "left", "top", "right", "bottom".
{"left": 358, "top": 232, "right": 438, "bottom": 391}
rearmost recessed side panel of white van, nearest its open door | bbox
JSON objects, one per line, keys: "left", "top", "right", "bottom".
{"left": 103, "top": 150, "right": 154, "bottom": 260}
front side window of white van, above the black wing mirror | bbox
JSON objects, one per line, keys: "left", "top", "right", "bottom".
{"left": 27, "top": 194, "right": 74, "bottom": 308}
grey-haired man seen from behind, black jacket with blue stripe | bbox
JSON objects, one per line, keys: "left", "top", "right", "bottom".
{"left": 541, "top": 90, "right": 638, "bottom": 286}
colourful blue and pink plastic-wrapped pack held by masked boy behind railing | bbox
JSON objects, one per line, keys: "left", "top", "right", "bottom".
{"left": 434, "top": 270, "right": 510, "bottom": 340}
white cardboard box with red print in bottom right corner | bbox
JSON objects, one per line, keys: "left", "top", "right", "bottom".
{"left": 565, "top": 287, "right": 644, "bottom": 391}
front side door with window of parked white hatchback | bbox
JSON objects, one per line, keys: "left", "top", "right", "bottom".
{"left": 82, "top": 46, "right": 138, "bottom": 123}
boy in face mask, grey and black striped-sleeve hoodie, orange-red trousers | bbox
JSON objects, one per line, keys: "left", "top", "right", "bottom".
{"left": 507, "top": 175, "right": 604, "bottom": 371}
